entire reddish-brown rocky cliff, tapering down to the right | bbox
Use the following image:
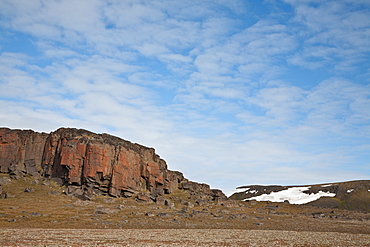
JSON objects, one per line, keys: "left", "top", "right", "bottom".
{"left": 0, "top": 128, "right": 226, "bottom": 201}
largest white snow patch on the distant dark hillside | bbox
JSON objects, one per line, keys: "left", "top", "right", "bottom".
{"left": 244, "top": 186, "right": 335, "bottom": 204}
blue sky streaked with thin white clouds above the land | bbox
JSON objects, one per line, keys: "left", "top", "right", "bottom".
{"left": 0, "top": 0, "right": 370, "bottom": 191}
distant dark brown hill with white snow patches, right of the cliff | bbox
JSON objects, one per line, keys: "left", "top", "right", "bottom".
{"left": 229, "top": 180, "right": 370, "bottom": 212}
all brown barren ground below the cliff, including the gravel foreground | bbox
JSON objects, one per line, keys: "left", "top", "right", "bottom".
{"left": 0, "top": 177, "right": 370, "bottom": 246}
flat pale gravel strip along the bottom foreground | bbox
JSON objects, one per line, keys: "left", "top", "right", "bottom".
{"left": 0, "top": 229, "right": 370, "bottom": 247}
